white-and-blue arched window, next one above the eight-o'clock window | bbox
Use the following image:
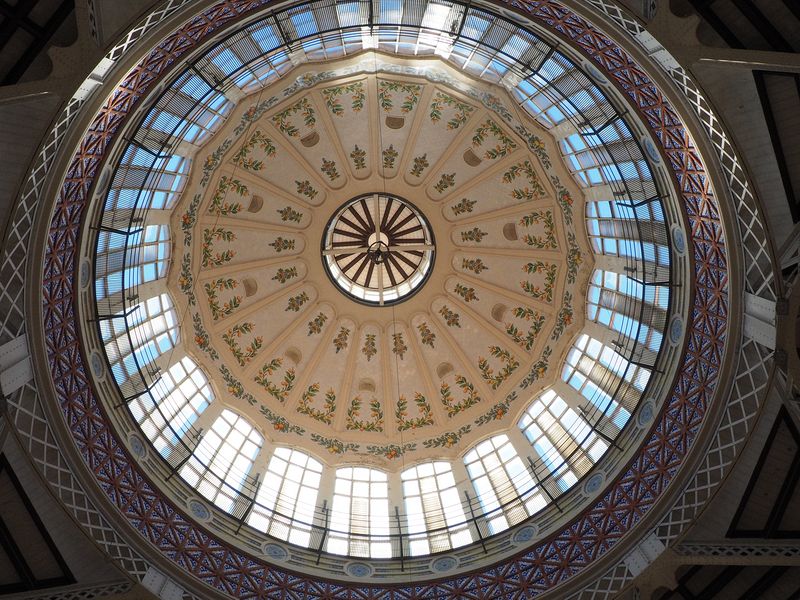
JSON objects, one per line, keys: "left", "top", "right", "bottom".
{"left": 100, "top": 294, "right": 178, "bottom": 386}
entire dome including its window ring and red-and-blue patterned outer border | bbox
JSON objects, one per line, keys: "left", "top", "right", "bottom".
{"left": 25, "top": 2, "right": 764, "bottom": 597}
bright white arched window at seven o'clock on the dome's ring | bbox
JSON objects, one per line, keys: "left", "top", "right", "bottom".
{"left": 247, "top": 448, "right": 322, "bottom": 546}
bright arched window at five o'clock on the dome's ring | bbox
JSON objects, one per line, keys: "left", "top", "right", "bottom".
{"left": 464, "top": 434, "right": 535, "bottom": 534}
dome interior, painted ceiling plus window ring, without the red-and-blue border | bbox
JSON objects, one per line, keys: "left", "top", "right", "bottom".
{"left": 89, "top": 16, "right": 685, "bottom": 572}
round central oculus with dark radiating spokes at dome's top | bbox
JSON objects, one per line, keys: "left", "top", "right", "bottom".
{"left": 322, "top": 193, "right": 436, "bottom": 306}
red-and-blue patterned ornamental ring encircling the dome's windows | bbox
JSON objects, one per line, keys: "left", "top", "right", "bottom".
{"left": 34, "top": 0, "right": 740, "bottom": 598}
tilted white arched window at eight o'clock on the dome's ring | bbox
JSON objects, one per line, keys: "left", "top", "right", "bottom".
{"left": 129, "top": 356, "right": 214, "bottom": 456}
